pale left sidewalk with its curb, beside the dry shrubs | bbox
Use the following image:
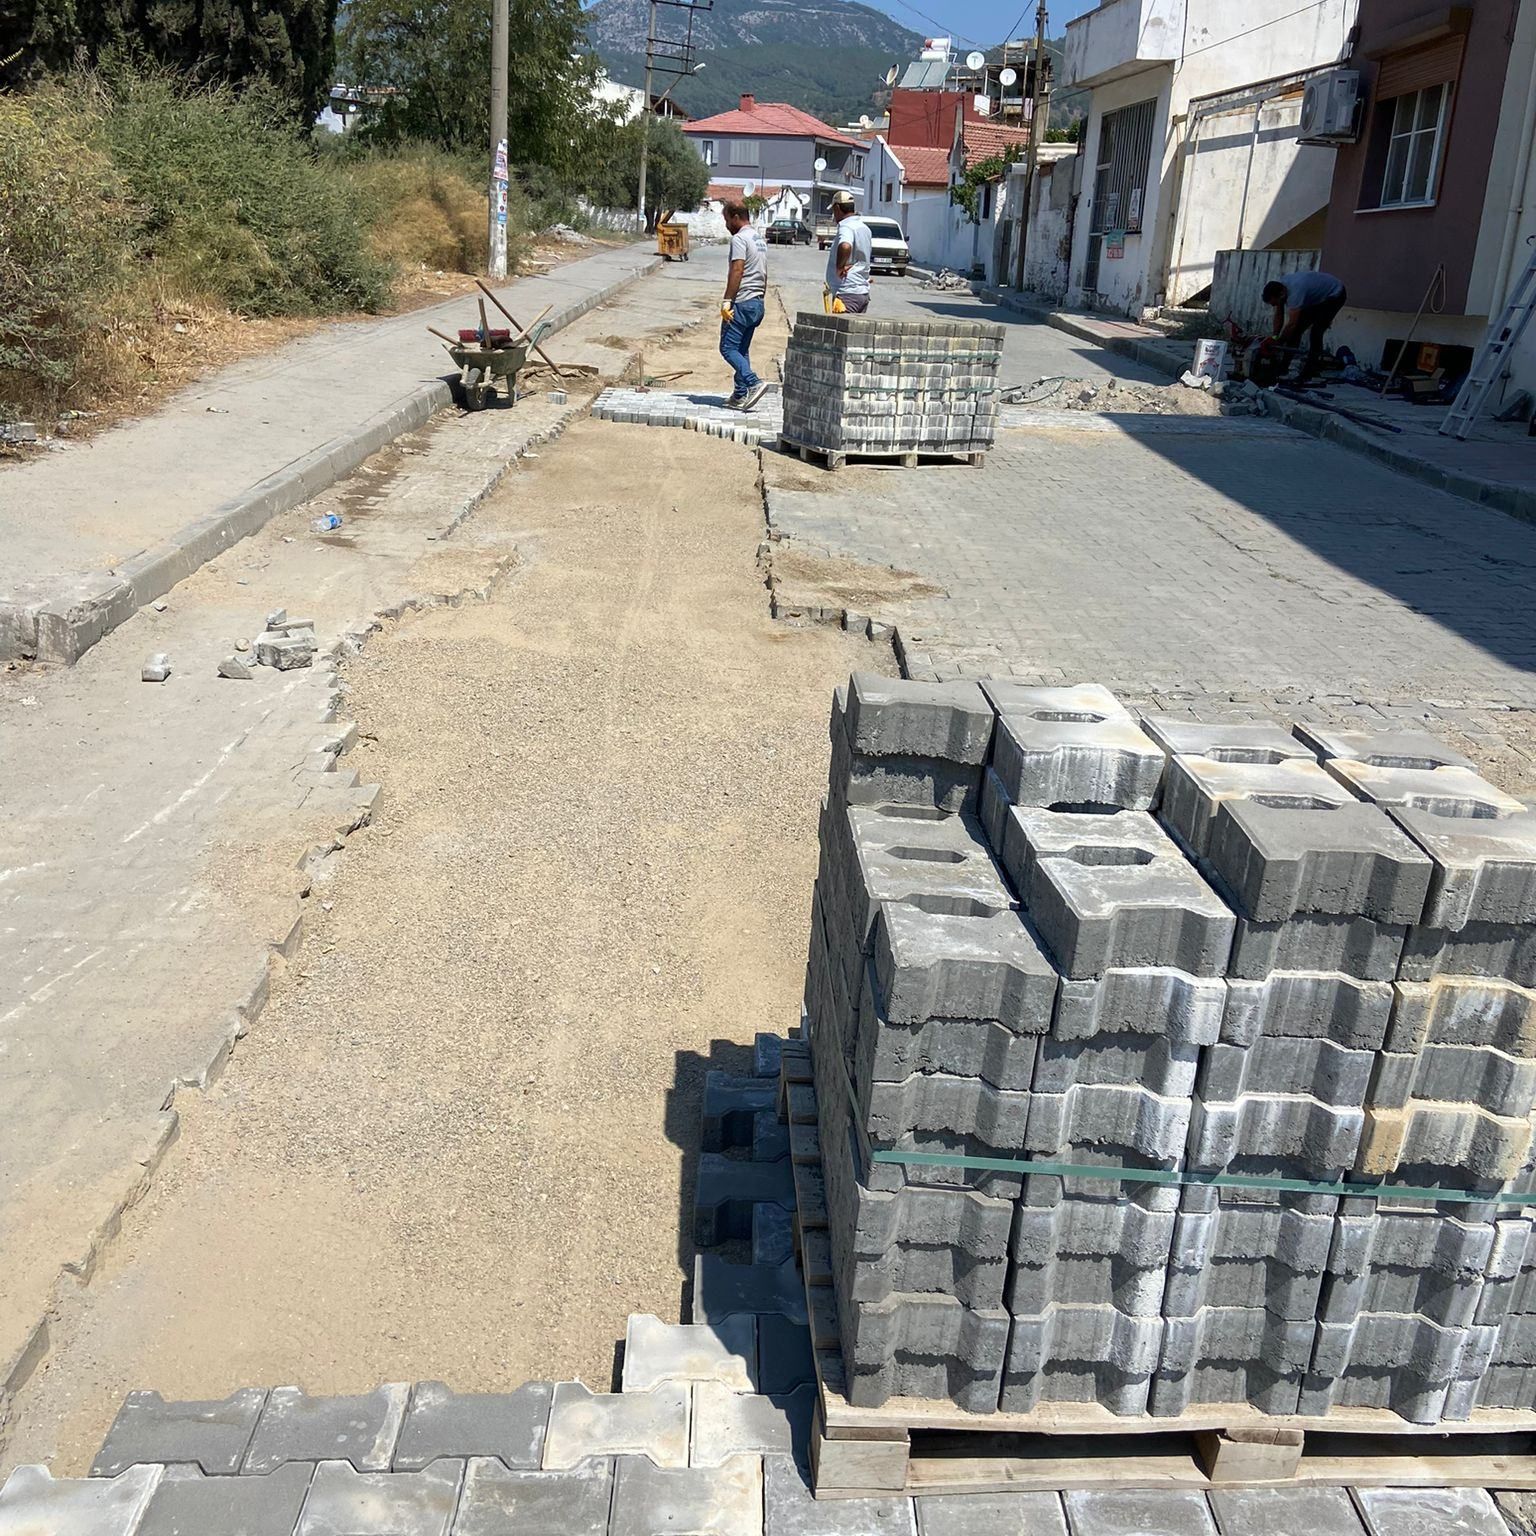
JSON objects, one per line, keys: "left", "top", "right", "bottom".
{"left": 0, "top": 244, "right": 656, "bottom": 662}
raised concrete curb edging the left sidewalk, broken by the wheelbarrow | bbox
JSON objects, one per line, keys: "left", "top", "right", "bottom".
{"left": 0, "top": 257, "right": 662, "bottom": 665}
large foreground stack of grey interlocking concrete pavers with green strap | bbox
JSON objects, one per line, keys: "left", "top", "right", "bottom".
{"left": 805, "top": 674, "right": 1536, "bottom": 1424}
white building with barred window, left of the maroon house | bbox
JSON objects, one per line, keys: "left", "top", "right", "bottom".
{"left": 1061, "top": 0, "right": 1356, "bottom": 315}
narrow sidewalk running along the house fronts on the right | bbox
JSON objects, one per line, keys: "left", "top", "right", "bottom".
{"left": 982, "top": 289, "right": 1536, "bottom": 522}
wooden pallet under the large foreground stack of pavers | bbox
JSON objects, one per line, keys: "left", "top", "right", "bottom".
{"left": 779, "top": 1040, "right": 1536, "bottom": 1499}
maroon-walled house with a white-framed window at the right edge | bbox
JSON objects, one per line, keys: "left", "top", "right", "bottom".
{"left": 1321, "top": 0, "right": 1536, "bottom": 409}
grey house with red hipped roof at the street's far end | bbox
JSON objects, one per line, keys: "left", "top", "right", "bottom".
{"left": 684, "top": 95, "right": 869, "bottom": 227}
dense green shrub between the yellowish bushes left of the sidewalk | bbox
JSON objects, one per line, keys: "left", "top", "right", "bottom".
{"left": 104, "top": 75, "right": 390, "bottom": 315}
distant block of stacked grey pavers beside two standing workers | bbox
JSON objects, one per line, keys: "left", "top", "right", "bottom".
{"left": 783, "top": 313, "right": 1003, "bottom": 455}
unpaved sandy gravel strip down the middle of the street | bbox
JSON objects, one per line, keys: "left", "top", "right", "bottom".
{"left": 5, "top": 305, "right": 891, "bottom": 1473}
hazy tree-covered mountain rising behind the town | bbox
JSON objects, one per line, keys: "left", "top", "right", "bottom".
{"left": 587, "top": 0, "right": 922, "bottom": 126}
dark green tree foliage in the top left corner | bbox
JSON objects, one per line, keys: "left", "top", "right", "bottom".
{"left": 0, "top": 0, "right": 336, "bottom": 124}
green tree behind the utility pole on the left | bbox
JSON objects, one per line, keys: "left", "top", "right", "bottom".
{"left": 339, "top": 0, "right": 601, "bottom": 178}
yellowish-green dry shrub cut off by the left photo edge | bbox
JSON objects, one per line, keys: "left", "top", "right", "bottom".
{"left": 0, "top": 89, "right": 129, "bottom": 407}
